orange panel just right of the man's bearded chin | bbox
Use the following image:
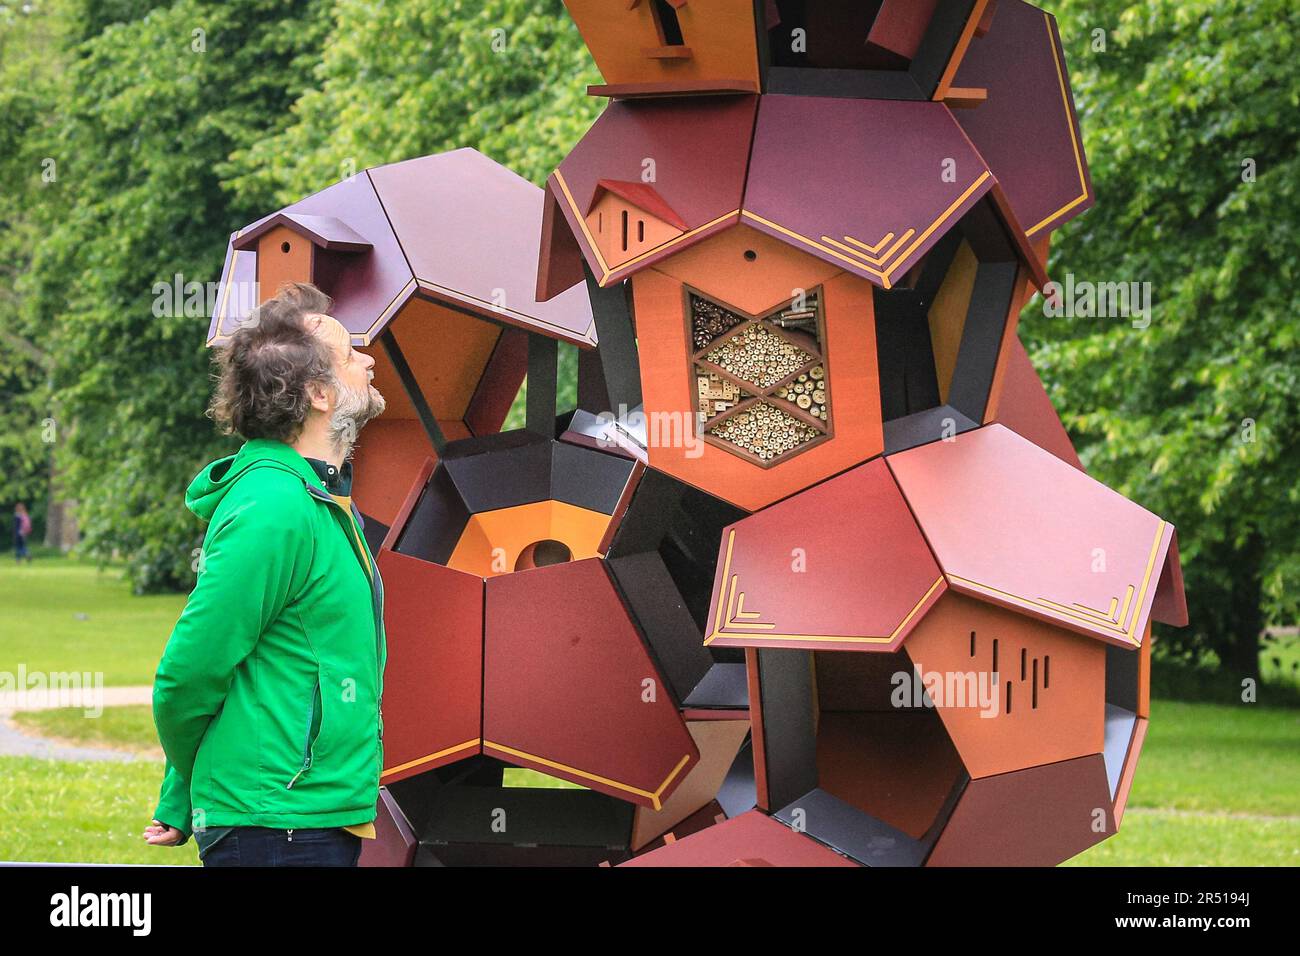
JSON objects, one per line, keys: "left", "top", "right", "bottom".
{"left": 352, "top": 416, "right": 469, "bottom": 524}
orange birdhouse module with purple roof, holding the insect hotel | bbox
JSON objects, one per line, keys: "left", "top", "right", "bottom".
{"left": 541, "top": 90, "right": 1045, "bottom": 510}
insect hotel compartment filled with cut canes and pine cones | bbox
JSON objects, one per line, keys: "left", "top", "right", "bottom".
{"left": 686, "top": 289, "right": 831, "bottom": 467}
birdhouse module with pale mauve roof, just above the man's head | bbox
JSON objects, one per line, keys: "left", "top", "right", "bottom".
{"left": 209, "top": 150, "right": 595, "bottom": 545}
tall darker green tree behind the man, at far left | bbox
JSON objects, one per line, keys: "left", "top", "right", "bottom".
{"left": 17, "top": 0, "right": 328, "bottom": 591}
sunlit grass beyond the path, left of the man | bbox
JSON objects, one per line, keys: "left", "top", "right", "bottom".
{"left": 0, "top": 555, "right": 186, "bottom": 687}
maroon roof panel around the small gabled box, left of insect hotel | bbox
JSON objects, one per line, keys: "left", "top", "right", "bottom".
{"left": 549, "top": 95, "right": 758, "bottom": 284}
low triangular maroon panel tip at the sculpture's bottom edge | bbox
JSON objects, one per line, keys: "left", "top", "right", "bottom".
{"left": 619, "top": 811, "right": 863, "bottom": 866}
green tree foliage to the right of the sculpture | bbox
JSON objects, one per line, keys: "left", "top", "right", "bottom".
{"left": 1021, "top": 0, "right": 1300, "bottom": 680}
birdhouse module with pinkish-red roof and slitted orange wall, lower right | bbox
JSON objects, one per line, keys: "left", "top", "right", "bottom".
{"left": 705, "top": 425, "right": 1186, "bottom": 865}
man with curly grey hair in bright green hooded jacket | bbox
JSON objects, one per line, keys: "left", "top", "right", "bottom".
{"left": 144, "top": 284, "right": 387, "bottom": 866}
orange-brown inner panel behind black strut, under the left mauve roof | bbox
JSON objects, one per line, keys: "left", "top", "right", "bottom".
{"left": 367, "top": 299, "right": 501, "bottom": 421}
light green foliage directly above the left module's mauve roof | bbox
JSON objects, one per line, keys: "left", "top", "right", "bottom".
{"left": 228, "top": 0, "right": 605, "bottom": 204}
